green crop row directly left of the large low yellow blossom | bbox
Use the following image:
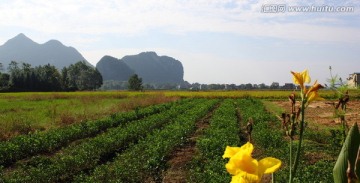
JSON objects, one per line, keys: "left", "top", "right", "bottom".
{"left": 188, "top": 99, "right": 240, "bottom": 182}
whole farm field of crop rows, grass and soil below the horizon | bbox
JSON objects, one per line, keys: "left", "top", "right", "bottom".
{"left": 0, "top": 91, "right": 360, "bottom": 182}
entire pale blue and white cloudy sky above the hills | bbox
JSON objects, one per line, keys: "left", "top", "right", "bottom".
{"left": 0, "top": 0, "right": 360, "bottom": 85}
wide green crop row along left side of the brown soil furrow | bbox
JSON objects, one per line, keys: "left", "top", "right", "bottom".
{"left": 76, "top": 100, "right": 218, "bottom": 183}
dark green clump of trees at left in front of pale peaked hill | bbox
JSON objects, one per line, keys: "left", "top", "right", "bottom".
{"left": 0, "top": 61, "right": 103, "bottom": 91}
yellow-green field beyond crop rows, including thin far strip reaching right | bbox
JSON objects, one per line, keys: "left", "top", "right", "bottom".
{"left": 0, "top": 90, "right": 360, "bottom": 139}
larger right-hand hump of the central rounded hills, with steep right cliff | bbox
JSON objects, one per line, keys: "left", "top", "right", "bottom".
{"left": 121, "top": 52, "right": 184, "bottom": 83}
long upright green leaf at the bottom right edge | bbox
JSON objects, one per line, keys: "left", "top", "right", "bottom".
{"left": 333, "top": 123, "right": 360, "bottom": 183}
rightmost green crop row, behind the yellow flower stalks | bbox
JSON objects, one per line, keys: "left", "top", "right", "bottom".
{"left": 239, "top": 98, "right": 335, "bottom": 182}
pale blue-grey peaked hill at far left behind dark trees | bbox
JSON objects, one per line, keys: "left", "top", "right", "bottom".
{"left": 0, "top": 33, "right": 91, "bottom": 69}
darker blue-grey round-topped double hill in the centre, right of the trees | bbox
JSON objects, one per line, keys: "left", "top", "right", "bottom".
{"left": 96, "top": 52, "right": 184, "bottom": 83}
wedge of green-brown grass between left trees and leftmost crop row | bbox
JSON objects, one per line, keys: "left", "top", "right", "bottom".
{"left": 0, "top": 92, "right": 179, "bottom": 140}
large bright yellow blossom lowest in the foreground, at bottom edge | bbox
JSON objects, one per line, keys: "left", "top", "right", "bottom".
{"left": 223, "top": 142, "right": 281, "bottom": 183}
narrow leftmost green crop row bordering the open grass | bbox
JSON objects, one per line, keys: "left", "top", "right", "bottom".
{"left": 0, "top": 99, "right": 186, "bottom": 166}
